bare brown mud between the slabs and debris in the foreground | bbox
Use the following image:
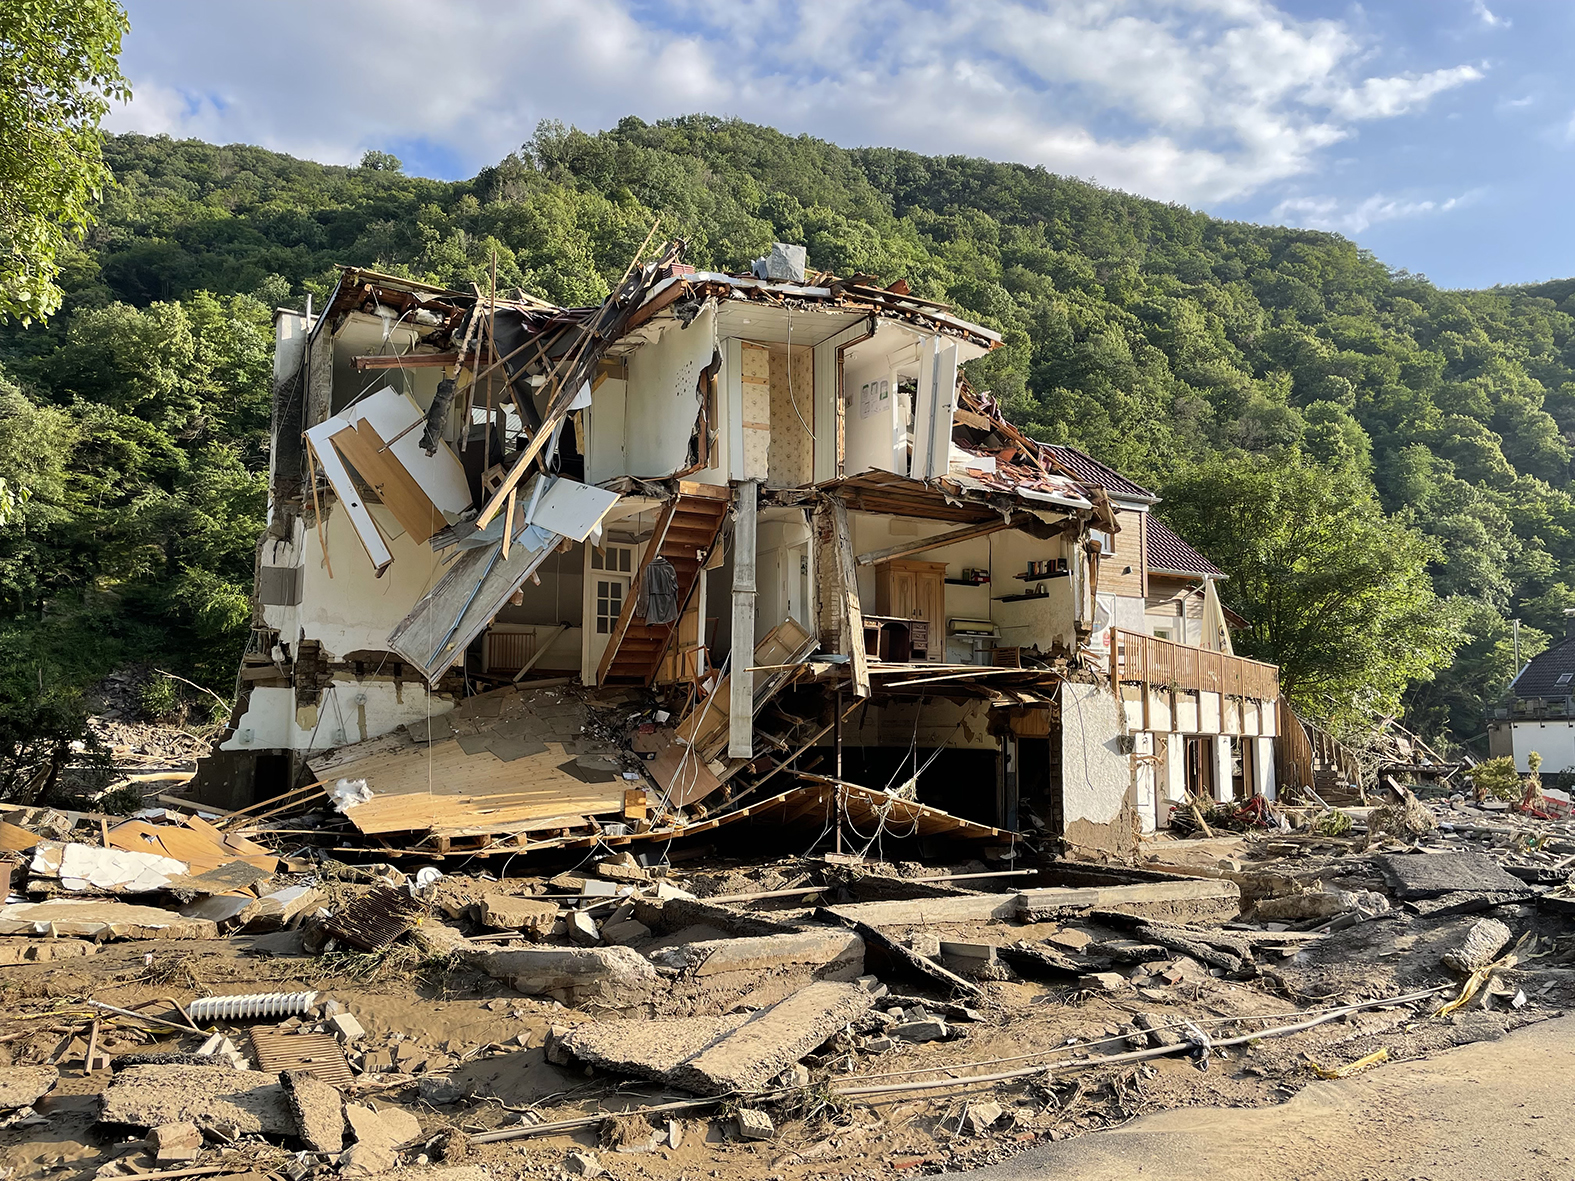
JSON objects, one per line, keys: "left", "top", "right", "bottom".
{"left": 0, "top": 839, "right": 1575, "bottom": 1181}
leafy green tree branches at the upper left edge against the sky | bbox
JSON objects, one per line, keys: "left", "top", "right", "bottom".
{"left": 0, "top": 0, "right": 131, "bottom": 323}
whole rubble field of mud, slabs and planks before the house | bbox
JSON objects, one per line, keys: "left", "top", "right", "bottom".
{"left": 0, "top": 798, "right": 1575, "bottom": 1181}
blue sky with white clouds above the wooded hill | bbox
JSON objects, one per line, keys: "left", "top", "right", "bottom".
{"left": 109, "top": 0, "right": 1575, "bottom": 287}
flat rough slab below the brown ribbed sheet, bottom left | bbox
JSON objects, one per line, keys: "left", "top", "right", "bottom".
{"left": 99, "top": 1066, "right": 296, "bottom": 1135}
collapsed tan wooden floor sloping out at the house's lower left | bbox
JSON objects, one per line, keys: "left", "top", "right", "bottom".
{"left": 310, "top": 690, "right": 627, "bottom": 836}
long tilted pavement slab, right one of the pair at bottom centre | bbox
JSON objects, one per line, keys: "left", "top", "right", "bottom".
{"left": 673, "top": 981, "right": 874, "bottom": 1094}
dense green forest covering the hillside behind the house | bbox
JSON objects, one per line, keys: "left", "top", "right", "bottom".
{"left": 0, "top": 115, "right": 1575, "bottom": 771}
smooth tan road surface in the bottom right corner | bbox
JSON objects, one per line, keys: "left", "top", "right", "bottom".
{"left": 953, "top": 1017, "right": 1575, "bottom": 1181}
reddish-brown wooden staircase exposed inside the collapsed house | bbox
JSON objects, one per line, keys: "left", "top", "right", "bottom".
{"left": 595, "top": 483, "right": 732, "bottom": 685}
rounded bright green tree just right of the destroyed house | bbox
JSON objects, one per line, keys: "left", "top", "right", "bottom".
{"left": 1164, "top": 458, "right": 1458, "bottom": 727}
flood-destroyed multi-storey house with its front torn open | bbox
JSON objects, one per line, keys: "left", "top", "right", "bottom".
{"left": 202, "top": 244, "right": 1284, "bottom": 853}
